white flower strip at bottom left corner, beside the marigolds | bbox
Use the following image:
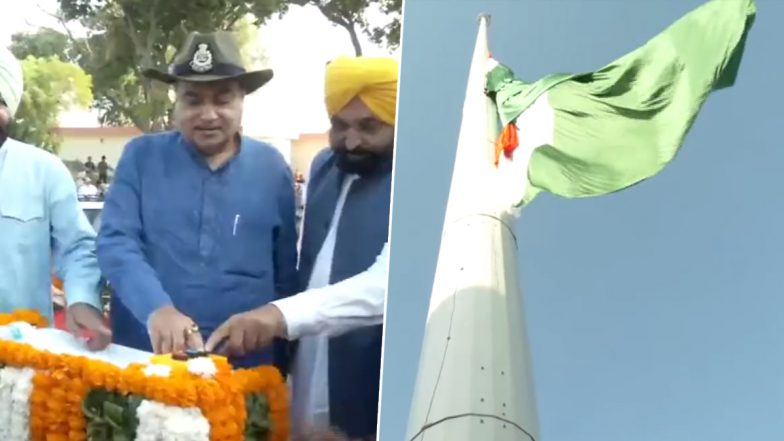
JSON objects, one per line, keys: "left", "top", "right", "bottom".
{"left": 0, "top": 367, "right": 35, "bottom": 441}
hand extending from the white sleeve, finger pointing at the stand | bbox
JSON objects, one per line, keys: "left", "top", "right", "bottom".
{"left": 205, "top": 305, "right": 287, "bottom": 356}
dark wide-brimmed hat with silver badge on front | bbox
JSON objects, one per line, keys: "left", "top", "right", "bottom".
{"left": 142, "top": 31, "right": 272, "bottom": 93}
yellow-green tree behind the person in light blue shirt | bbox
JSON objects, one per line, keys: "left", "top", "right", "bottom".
{"left": 9, "top": 55, "right": 93, "bottom": 153}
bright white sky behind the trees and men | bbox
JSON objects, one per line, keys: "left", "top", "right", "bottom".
{"left": 0, "top": 0, "right": 399, "bottom": 138}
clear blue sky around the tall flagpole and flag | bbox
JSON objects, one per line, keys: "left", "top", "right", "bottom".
{"left": 380, "top": 0, "right": 784, "bottom": 441}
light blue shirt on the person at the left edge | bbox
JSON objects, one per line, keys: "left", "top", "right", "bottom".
{"left": 0, "top": 138, "right": 101, "bottom": 323}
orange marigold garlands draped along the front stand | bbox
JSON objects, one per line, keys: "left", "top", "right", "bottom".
{"left": 0, "top": 310, "right": 289, "bottom": 441}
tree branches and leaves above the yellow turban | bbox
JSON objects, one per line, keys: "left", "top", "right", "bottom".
{"left": 289, "top": 0, "right": 403, "bottom": 56}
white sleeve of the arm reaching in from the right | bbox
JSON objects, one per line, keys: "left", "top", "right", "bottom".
{"left": 272, "top": 244, "right": 389, "bottom": 340}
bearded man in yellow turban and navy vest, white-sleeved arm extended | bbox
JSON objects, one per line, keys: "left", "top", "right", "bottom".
{"left": 207, "top": 57, "right": 398, "bottom": 440}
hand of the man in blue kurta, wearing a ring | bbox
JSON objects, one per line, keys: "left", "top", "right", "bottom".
{"left": 148, "top": 305, "right": 204, "bottom": 354}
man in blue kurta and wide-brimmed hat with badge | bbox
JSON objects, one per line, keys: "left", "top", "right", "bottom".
{"left": 98, "top": 32, "right": 297, "bottom": 371}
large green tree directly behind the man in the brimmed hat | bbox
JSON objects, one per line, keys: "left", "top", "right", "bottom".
{"left": 49, "top": 0, "right": 284, "bottom": 131}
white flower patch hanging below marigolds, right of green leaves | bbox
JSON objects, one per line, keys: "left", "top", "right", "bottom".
{"left": 135, "top": 400, "right": 210, "bottom": 441}
